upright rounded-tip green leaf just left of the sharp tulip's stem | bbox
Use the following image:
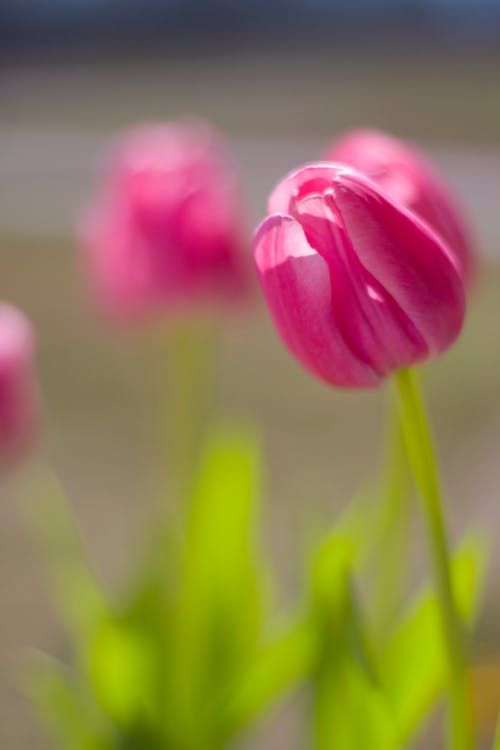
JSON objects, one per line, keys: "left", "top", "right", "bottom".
{"left": 311, "top": 533, "right": 398, "bottom": 750}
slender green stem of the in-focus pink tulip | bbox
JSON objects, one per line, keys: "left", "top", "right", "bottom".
{"left": 396, "top": 370, "right": 474, "bottom": 750}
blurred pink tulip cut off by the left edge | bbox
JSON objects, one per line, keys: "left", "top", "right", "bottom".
{"left": 0, "top": 302, "right": 39, "bottom": 469}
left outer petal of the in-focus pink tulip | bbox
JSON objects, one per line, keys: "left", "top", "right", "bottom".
{"left": 254, "top": 214, "right": 380, "bottom": 388}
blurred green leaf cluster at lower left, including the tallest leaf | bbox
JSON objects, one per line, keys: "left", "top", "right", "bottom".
{"left": 29, "top": 434, "right": 296, "bottom": 750}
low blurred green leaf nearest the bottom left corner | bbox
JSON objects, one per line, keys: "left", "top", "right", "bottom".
{"left": 24, "top": 654, "right": 116, "bottom": 750}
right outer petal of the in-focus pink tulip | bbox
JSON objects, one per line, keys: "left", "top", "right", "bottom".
{"left": 334, "top": 173, "right": 465, "bottom": 353}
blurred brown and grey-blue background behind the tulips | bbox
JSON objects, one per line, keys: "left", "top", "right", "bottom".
{"left": 0, "top": 0, "right": 500, "bottom": 750}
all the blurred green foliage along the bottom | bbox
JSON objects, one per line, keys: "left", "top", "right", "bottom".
{"left": 23, "top": 433, "right": 485, "bottom": 750}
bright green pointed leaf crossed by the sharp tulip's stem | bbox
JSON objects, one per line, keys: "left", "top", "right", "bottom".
{"left": 381, "top": 535, "right": 485, "bottom": 743}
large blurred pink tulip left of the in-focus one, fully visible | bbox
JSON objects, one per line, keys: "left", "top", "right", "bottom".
{"left": 81, "top": 123, "right": 249, "bottom": 318}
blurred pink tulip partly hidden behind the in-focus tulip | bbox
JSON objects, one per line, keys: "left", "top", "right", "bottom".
{"left": 325, "top": 130, "right": 475, "bottom": 280}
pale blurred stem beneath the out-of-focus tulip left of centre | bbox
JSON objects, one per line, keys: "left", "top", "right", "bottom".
{"left": 133, "top": 317, "right": 217, "bottom": 590}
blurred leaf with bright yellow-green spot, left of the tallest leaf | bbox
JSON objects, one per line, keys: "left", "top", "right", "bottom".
{"left": 94, "top": 516, "right": 179, "bottom": 736}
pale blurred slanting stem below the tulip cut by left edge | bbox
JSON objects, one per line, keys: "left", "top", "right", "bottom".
{"left": 24, "top": 470, "right": 107, "bottom": 644}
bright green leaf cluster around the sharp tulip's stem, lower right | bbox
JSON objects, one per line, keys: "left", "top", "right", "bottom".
{"left": 311, "top": 506, "right": 486, "bottom": 750}
